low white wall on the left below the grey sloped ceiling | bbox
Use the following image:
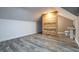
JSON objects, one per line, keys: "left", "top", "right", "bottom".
{"left": 0, "top": 19, "right": 36, "bottom": 41}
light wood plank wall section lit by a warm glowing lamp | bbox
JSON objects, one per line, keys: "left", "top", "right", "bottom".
{"left": 42, "top": 11, "right": 58, "bottom": 35}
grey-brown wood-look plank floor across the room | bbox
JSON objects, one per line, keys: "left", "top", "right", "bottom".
{"left": 0, "top": 34, "right": 79, "bottom": 52}
